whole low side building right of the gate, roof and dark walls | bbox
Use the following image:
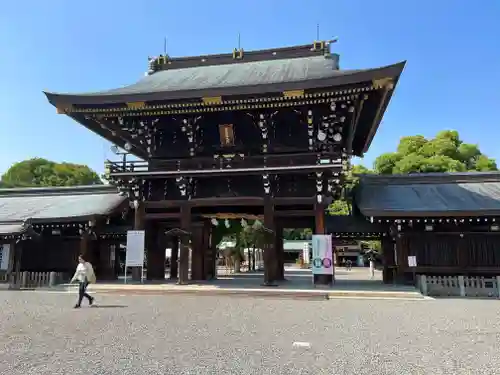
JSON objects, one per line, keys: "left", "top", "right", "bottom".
{"left": 354, "top": 172, "right": 500, "bottom": 283}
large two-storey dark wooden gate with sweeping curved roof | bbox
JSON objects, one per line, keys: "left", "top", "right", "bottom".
{"left": 46, "top": 41, "right": 405, "bottom": 283}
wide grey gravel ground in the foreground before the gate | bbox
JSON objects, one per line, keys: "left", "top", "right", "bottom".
{"left": 0, "top": 292, "right": 500, "bottom": 375}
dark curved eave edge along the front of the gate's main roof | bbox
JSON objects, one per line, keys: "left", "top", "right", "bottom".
{"left": 44, "top": 61, "right": 406, "bottom": 107}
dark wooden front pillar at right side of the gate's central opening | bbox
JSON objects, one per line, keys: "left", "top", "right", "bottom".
{"left": 263, "top": 198, "right": 278, "bottom": 285}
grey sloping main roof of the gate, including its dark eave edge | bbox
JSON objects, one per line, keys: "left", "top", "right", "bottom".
{"left": 46, "top": 55, "right": 404, "bottom": 104}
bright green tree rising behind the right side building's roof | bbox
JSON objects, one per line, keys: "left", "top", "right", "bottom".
{"left": 373, "top": 130, "right": 497, "bottom": 174}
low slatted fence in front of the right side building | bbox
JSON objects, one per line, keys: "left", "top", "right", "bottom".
{"left": 417, "top": 275, "right": 500, "bottom": 298}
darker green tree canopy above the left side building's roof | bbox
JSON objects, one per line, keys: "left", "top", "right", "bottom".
{"left": 0, "top": 158, "right": 102, "bottom": 188}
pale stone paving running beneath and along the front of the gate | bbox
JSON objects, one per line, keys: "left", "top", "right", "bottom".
{"left": 52, "top": 268, "right": 424, "bottom": 299}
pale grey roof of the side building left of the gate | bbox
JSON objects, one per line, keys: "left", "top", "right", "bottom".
{"left": 0, "top": 185, "right": 126, "bottom": 234}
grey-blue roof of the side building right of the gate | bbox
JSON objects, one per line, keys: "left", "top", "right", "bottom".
{"left": 355, "top": 172, "right": 500, "bottom": 217}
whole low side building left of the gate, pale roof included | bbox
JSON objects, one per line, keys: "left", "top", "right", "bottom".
{"left": 0, "top": 185, "right": 133, "bottom": 283}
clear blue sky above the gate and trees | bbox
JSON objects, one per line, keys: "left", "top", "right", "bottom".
{"left": 0, "top": 0, "right": 500, "bottom": 176}
